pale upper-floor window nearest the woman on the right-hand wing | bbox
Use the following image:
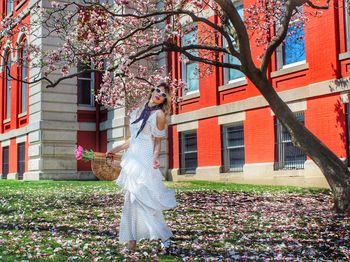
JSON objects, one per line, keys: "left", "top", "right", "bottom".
{"left": 181, "top": 28, "right": 199, "bottom": 94}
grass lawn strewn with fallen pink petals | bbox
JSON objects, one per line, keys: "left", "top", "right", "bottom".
{"left": 0, "top": 180, "right": 350, "bottom": 261}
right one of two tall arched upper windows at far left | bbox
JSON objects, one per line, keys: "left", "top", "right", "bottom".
{"left": 19, "top": 43, "right": 28, "bottom": 113}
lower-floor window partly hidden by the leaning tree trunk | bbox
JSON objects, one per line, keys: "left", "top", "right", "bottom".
{"left": 274, "top": 112, "right": 306, "bottom": 170}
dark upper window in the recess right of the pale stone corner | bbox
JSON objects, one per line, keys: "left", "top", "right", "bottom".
{"left": 78, "top": 63, "right": 95, "bottom": 106}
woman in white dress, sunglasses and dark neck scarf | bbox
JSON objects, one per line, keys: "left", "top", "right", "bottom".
{"left": 107, "top": 83, "right": 176, "bottom": 251}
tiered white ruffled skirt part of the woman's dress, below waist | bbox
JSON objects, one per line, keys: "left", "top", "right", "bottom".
{"left": 116, "top": 148, "right": 176, "bottom": 242}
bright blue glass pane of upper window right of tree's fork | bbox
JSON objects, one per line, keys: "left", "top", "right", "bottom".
{"left": 283, "top": 22, "right": 306, "bottom": 65}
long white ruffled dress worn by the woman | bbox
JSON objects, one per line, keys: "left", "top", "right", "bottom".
{"left": 116, "top": 108, "right": 176, "bottom": 242}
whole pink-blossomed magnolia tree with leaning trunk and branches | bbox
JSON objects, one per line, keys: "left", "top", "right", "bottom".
{"left": 2, "top": 0, "right": 350, "bottom": 213}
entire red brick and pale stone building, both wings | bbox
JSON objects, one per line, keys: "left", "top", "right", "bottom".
{"left": 0, "top": 0, "right": 350, "bottom": 186}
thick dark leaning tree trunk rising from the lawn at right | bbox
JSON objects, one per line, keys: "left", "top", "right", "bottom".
{"left": 247, "top": 69, "right": 350, "bottom": 214}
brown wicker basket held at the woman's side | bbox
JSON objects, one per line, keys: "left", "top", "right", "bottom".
{"left": 91, "top": 152, "right": 122, "bottom": 181}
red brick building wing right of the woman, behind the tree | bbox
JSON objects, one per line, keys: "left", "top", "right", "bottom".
{"left": 169, "top": 1, "right": 350, "bottom": 186}
